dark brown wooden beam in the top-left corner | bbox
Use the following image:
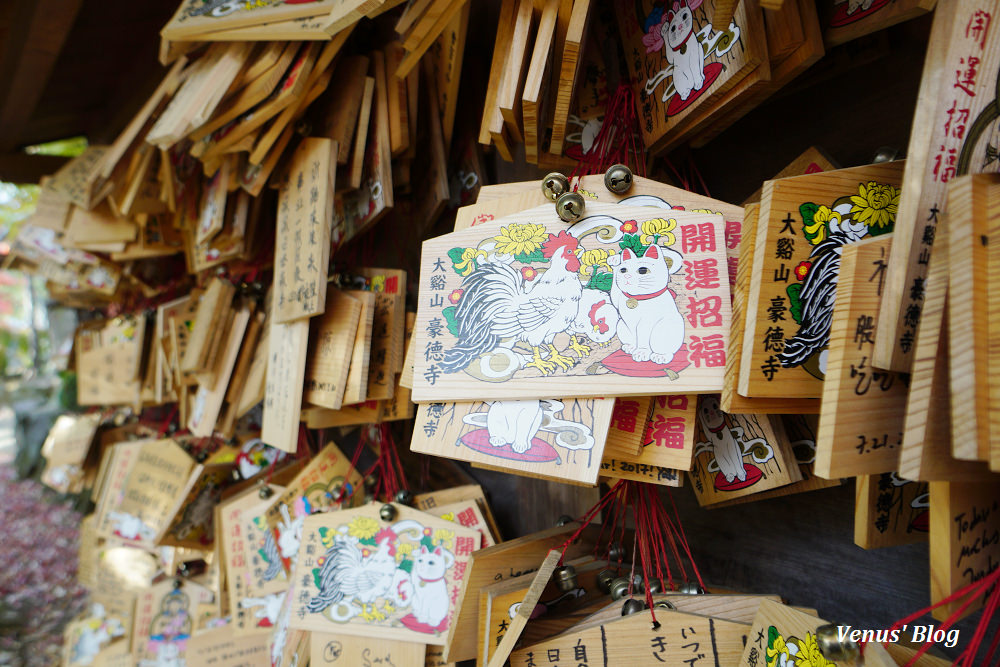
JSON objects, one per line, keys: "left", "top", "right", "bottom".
{"left": 0, "top": 0, "right": 83, "bottom": 152}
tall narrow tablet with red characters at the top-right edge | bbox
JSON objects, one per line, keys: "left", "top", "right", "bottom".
{"left": 873, "top": 0, "right": 1000, "bottom": 373}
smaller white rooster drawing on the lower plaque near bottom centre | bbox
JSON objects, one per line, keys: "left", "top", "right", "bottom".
{"left": 308, "top": 537, "right": 396, "bottom": 621}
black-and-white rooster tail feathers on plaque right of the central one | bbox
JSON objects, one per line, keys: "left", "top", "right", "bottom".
{"left": 778, "top": 232, "right": 852, "bottom": 372}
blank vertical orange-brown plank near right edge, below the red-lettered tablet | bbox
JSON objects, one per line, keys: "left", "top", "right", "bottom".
{"left": 944, "top": 174, "right": 1000, "bottom": 461}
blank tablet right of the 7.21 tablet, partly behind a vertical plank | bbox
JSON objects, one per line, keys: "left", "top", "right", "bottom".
{"left": 899, "top": 218, "right": 989, "bottom": 481}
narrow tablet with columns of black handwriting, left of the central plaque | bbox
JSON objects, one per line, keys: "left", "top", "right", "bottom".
{"left": 273, "top": 137, "right": 336, "bottom": 324}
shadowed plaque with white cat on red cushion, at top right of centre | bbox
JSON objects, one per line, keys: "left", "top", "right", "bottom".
{"left": 617, "top": 0, "right": 767, "bottom": 153}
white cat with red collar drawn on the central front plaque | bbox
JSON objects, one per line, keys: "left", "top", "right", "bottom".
{"left": 608, "top": 245, "right": 684, "bottom": 364}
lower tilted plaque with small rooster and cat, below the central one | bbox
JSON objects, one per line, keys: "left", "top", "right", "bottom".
{"left": 290, "top": 505, "right": 480, "bottom": 645}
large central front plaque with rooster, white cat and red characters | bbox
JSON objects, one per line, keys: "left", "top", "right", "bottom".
{"left": 413, "top": 204, "right": 730, "bottom": 402}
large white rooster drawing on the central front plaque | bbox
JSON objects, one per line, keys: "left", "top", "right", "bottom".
{"left": 441, "top": 231, "right": 590, "bottom": 375}
